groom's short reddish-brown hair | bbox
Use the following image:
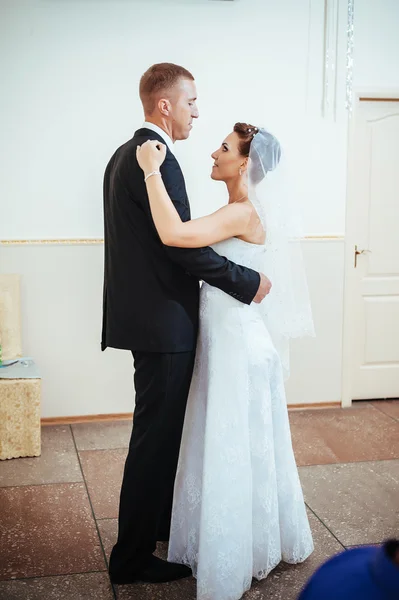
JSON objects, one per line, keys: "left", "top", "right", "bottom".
{"left": 140, "top": 63, "right": 194, "bottom": 114}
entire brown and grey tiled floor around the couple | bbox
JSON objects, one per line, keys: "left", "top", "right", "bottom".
{"left": 0, "top": 401, "right": 399, "bottom": 600}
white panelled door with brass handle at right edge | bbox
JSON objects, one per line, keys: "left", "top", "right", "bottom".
{"left": 343, "top": 94, "right": 399, "bottom": 405}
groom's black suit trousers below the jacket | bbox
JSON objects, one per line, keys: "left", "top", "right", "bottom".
{"left": 110, "top": 351, "right": 195, "bottom": 576}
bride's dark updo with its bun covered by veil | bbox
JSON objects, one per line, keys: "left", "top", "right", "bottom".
{"left": 234, "top": 123, "right": 281, "bottom": 185}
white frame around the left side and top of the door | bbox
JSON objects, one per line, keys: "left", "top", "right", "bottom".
{"left": 341, "top": 88, "right": 399, "bottom": 408}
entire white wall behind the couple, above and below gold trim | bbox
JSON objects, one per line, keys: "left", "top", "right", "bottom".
{"left": 0, "top": 0, "right": 399, "bottom": 417}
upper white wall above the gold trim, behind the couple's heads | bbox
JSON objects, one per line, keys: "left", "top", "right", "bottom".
{"left": 0, "top": 0, "right": 345, "bottom": 239}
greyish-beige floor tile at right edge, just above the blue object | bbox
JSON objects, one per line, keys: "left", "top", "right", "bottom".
{"left": 299, "top": 460, "right": 399, "bottom": 546}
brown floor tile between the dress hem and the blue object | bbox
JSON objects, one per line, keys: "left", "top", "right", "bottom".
{"left": 243, "top": 511, "right": 343, "bottom": 600}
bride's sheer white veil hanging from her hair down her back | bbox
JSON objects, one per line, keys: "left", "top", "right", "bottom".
{"left": 248, "top": 129, "right": 315, "bottom": 378}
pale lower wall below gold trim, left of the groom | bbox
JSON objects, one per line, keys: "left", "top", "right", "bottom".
{"left": 0, "top": 244, "right": 134, "bottom": 417}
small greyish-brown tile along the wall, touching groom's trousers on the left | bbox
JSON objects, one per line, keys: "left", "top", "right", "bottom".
{"left": 72, "top": 419, "right": 132, "bottom": 450}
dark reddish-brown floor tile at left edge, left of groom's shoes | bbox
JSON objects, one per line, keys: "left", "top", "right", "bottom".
{"left": 0, "top": 483, "right": 105, "bottom": 579}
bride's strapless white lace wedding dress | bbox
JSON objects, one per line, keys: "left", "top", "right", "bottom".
{"left": 168, "top": 238, "right": 313, "bottom": 600}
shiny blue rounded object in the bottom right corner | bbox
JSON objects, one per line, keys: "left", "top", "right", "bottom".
{"left": 298, "top": 540, "right": 399, "bottom": 600}
